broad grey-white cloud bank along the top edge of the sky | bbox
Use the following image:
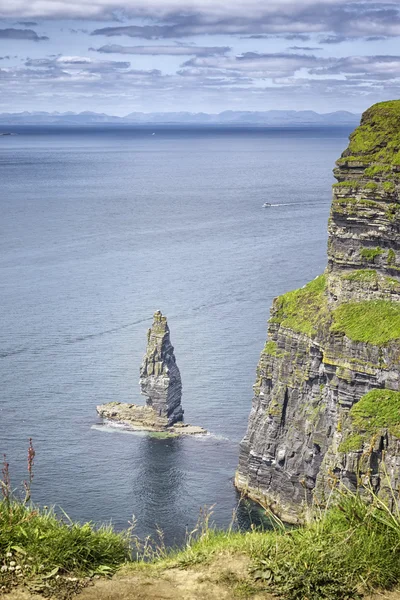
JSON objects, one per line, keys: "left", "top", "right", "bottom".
{"left": 0, "top": 0, "right": 400, "bottom": 43}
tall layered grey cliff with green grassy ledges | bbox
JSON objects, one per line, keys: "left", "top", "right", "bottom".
{"left": 236, "top": 101, "right": 400, "bottom": 522}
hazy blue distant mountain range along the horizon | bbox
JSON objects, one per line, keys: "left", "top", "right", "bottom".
{"left": 0, "top": 110, "right": 360, "bottom": 127}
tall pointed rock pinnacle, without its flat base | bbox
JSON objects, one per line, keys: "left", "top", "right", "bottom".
{"left": 139, "top": 310, "right": 183, "bottom": 426}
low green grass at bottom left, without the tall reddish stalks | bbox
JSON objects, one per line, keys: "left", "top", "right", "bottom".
{"left": 0, "top": 499, "right": 130, "bottom": 585}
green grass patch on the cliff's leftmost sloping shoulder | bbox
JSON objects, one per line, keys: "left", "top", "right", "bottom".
{"left": 270, "top": 275, "right": 327, "bottom": 336}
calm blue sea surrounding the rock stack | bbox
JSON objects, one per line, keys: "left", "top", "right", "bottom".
{"left": 0, "top": 128, "right": 349, "bottom": 543}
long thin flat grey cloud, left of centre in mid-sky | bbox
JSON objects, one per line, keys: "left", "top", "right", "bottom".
{"left": 89, "top": 44, "right": 231, "bottom": 56}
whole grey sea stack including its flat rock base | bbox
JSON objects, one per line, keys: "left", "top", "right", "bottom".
{"left": 97, "top": 310, "right": 207, "bottom": 435}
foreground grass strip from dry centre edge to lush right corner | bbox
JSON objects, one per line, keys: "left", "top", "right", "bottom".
{"left": 137, "top": 492, "right": 400, "bottom": 600}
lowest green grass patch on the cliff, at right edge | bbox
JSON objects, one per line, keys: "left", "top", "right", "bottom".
{"left": 339, "top": 389, "right": 400, "bottom": 452}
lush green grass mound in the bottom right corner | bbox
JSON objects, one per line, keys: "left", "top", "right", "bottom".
{"left": 254, "top": 493, "right": 400, "bottom": 600}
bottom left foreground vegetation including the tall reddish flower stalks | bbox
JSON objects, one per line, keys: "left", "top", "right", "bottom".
{"left": 0, "top": 440, "right": 130, "bottom": 595}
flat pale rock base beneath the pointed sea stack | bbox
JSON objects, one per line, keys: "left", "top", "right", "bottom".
{"left": 96, "top": 402, "right": 207, "bottom": 435}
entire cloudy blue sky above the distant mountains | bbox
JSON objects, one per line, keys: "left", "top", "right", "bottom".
{"left": 0, "top": 0, "right": 400, "bottom": 116}
